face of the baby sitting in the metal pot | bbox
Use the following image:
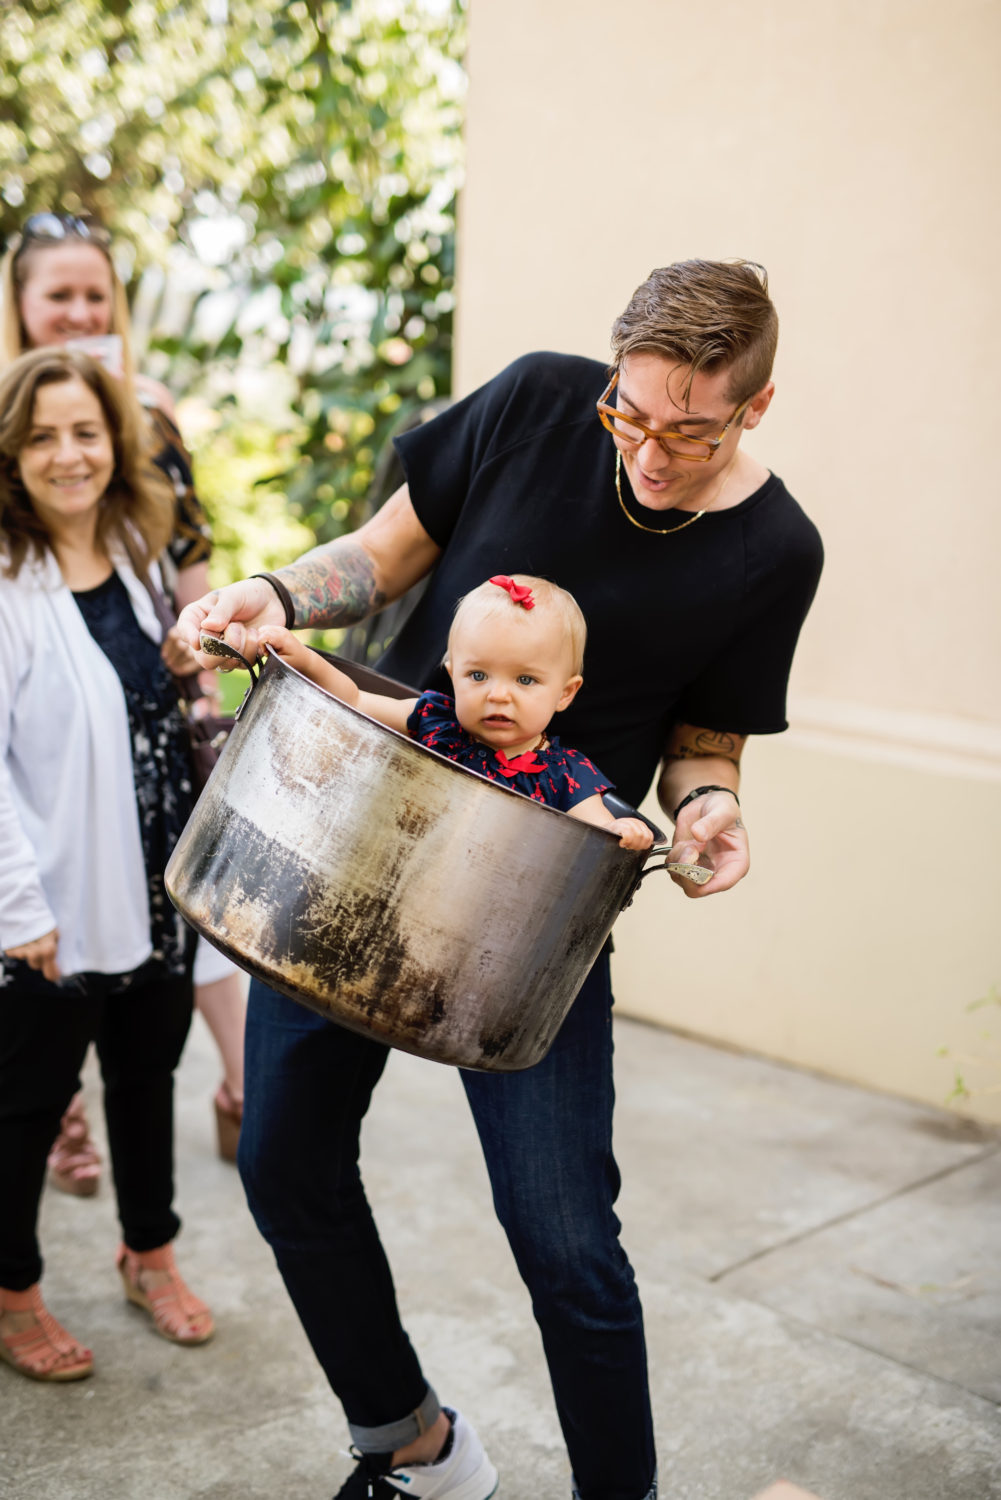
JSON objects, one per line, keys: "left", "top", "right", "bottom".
{"left": 446, "top": 611, "right": 581, "bottom": 759}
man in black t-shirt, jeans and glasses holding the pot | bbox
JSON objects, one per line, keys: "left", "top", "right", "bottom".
{"left": 180, "top": 261, "right": 822, "bottom": 1500}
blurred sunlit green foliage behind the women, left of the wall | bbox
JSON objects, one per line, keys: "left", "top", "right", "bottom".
{"left": 0, "top": 0, "right": 464, "bottom": 575}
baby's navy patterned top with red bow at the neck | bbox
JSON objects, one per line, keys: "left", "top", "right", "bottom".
{"left": 407, "top": 693, "right": 612, "bottom": 813}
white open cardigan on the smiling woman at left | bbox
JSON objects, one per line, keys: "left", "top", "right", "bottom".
{"left": 0, "top": 554, "right": 162, "bottom": 975}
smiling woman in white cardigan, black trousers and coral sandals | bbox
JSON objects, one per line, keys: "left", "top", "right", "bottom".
{"left": 0, "top": 350, "right": 213, "bottom": 1380}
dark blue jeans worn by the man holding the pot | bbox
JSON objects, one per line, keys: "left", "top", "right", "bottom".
{"left": 240, "top": 954, "right": 656, "bottom": 1500}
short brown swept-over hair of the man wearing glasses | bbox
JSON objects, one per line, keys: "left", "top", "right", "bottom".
{"left": 612, "top": 261, "right": 779, "bottom": 405}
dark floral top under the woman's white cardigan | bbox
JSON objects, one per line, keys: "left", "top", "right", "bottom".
{"left": 74, "top": 573, "right": 195, "bottom": 974}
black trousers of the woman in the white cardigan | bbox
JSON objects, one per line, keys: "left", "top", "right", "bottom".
{"left": 0, "top": 959, "right": 194, "bottom": 1292}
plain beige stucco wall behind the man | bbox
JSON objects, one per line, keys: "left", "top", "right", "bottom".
{"left": 456, "top": 0, "right": 1001, "bottom": 1121}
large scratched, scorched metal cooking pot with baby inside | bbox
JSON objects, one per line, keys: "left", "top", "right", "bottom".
{"left": 167, "top": 657, "right": 644, "bottom": 1071}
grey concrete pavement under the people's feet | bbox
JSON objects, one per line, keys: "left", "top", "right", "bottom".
{"left": 0, "top": 1020, "right": 1001, "bottom": 1500}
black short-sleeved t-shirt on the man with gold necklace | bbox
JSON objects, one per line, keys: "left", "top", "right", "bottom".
{"left": 380, "top": 354, "right": 822, "bottom": 806}
